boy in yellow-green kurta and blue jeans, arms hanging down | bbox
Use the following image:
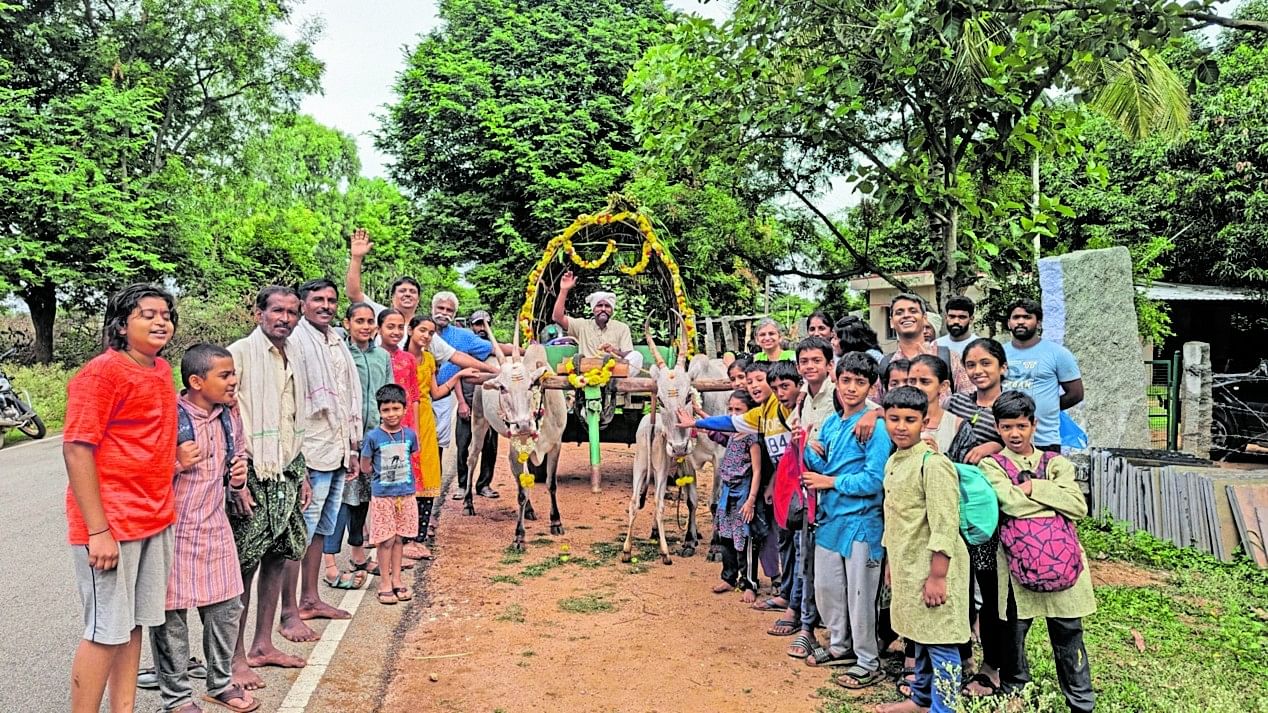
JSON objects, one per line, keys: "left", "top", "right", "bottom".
{"left": 877, "top": 386, "right": 969, "bottom": 713}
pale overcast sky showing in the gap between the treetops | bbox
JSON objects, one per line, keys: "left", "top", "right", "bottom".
{"left": 286, "top": 0, "right": 729, "bottom": 178}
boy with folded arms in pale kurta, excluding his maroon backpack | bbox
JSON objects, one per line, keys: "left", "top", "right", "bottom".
{"left": 981, "top": 391, "right": 1097, "bottom": 713}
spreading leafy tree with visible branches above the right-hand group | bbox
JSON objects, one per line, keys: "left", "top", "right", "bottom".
{"left": 629, "top": 0, "right": 1268, "bottom": 301}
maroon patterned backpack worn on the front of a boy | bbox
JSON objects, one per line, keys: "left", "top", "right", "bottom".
{"left": 992, "top": 452, "right": 1083, "bottom": 592}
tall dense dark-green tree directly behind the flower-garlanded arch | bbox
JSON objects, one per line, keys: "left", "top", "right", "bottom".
{"left": 378, "top": 0, "right": 762, "bottom": 319}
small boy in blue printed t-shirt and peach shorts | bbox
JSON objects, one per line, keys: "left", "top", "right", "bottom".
{"left": 361, "top": 383, "right": 418, "bottom": 604}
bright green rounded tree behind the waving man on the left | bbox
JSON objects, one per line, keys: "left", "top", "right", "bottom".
{"left": 185, "top": 115, "right": 458, "bottom": 298}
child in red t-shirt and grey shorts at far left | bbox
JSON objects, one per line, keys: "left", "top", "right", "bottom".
{"left": 62, "top": 284, "right": 181, "bottom": 713}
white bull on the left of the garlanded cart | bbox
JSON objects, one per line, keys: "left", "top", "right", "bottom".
{"left": 463, "top": 334, "right": 568, "bottom": 549}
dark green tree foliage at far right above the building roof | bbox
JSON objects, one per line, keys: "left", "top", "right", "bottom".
{"left": 1044, "top": 8, "right": 1268, "bottom": 291}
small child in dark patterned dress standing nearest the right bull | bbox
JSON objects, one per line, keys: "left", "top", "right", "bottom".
{"left": 713, "top": 389, "right": 766, "bottom": 604}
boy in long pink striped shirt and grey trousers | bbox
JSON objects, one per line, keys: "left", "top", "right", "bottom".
{"left": 150, "top": 344, "right": 260, "bottom": 713}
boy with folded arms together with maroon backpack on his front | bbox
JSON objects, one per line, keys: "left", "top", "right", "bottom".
{"left": 981, "top": 391, "right": 1097, "bottom": 713}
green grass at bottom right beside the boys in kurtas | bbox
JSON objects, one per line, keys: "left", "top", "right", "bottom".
{"left": 820, "top": 521, "right": 1268, "bottom": 713}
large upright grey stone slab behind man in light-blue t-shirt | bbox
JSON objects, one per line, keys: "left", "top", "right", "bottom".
{"left": 1038, "top": 247, "right": 1150, "bottom": 448}
